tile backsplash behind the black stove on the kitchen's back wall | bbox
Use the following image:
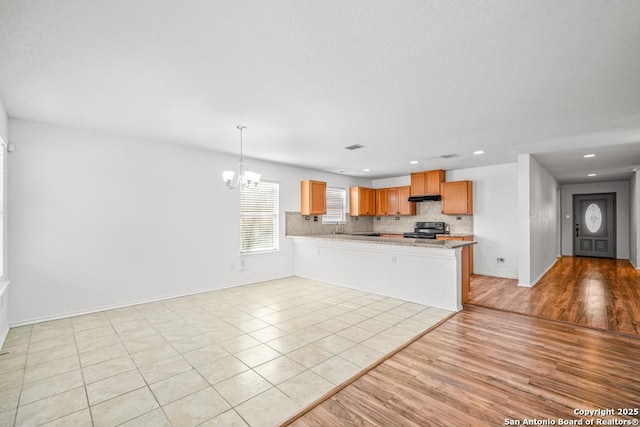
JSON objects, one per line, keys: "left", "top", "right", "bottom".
{"left": 373, "top": 201, "right": 473, "bottom": 234}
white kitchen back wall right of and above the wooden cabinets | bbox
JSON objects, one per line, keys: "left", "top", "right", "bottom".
{"left": 374, "top": 163, "right": 519, "bottom": 278}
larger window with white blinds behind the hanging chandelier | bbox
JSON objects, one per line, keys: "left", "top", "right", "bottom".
{"left": 240, "top": 181, "right": 280, "bottom": 253}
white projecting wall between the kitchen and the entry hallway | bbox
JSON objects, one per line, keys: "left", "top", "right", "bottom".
{"left": 518, "top": 154, "right": 560, "bottom": 286}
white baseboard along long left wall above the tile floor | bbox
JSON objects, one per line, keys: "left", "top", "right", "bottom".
{"left": 7, "top": 275, "right": 293, "bottom": 331}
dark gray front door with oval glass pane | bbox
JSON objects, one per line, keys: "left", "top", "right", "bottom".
{"left": 573, "top": 193, "right": 616, "bottom": 258}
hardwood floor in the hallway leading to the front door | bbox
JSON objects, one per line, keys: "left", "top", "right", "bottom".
{"left": 467, "top": 257, "right": 640, "bottom": 336}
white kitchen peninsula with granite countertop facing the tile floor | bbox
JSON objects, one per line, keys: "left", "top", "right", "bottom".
{"left": 288, "top": 234, "right": 476, "bottom": 311}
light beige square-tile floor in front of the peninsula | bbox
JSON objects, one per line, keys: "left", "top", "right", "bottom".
{"left": 0, "top": 277, "right": 450, "bottom": 427}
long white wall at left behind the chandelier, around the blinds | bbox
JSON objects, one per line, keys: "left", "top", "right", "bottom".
{"left": 9, "top": 120, "right": 371, "bottom": 324}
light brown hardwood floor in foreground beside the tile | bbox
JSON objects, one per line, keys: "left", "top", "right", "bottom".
{"left": 285, "top": 306, "right": 640, "bottom": 427}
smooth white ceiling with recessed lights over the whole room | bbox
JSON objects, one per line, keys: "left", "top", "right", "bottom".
{"left": 0, "top": 0, "right": 640, "bottom": 182}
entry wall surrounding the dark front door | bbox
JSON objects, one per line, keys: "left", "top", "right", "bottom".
{"left": 561, "top": 181, "right": 630, "bottom": 259}
